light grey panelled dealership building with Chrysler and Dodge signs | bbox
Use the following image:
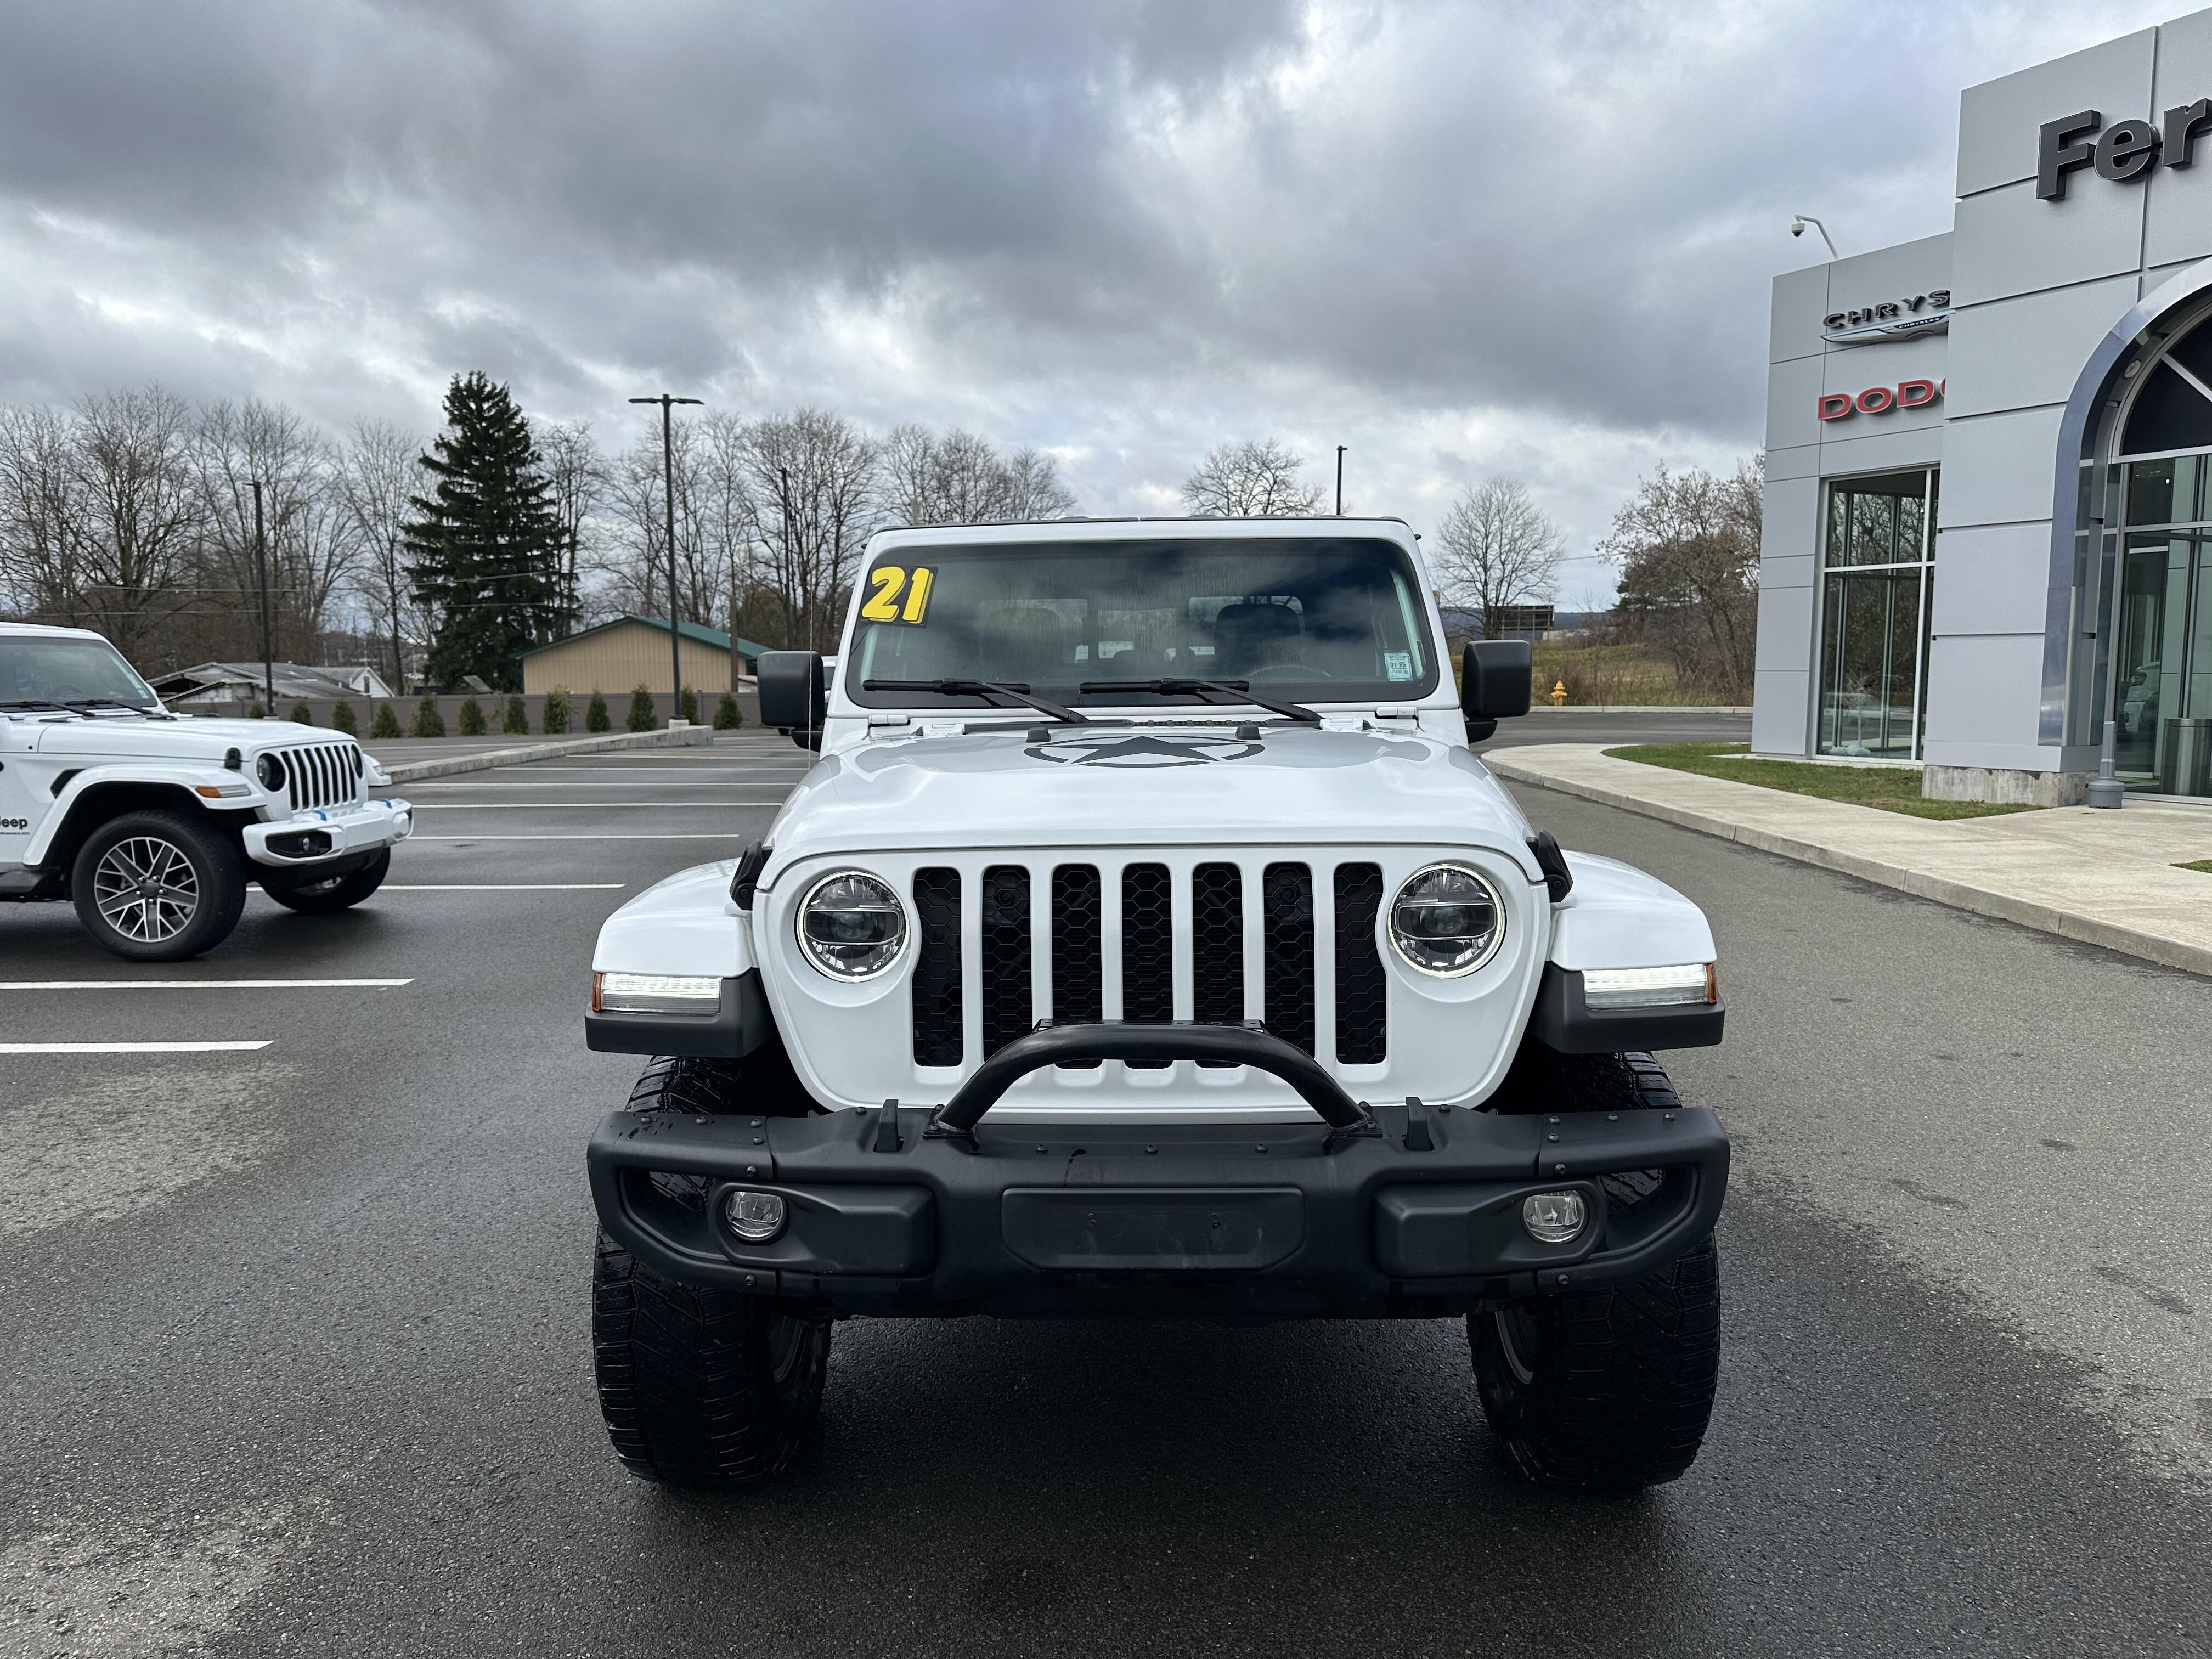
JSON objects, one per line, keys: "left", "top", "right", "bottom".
{"left": 1752, "top": 11, "right": 2212, "bottom": 805}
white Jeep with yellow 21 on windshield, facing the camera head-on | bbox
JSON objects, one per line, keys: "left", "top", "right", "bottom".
{"left": 586, "top": 517, "right": 1728, "bottom": 1489}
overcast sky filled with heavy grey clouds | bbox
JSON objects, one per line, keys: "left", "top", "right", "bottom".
{"left": 0, "top": 0, "right": 2176, "bottom": 604}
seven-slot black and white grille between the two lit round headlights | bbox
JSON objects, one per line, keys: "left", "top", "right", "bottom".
{"left": 913, "top": 860, "right": 1389, "bottom": 1070}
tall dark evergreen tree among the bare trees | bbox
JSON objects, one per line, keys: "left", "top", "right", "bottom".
{"left": 407, "top": 371, "right": 575, "bottom": 690}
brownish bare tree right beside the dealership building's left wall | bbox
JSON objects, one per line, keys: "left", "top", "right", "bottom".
{"left": 1597, "top": 456, "right": 1765, "bottom": 701}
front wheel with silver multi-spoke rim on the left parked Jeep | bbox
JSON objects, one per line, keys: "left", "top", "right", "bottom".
{"left": 69, "top": 812, "right": 246, "bottom": 962}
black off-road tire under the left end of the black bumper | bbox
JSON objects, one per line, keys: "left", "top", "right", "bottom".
{"left": 591, "top": 1051, "right": 830, "bottom": 1487}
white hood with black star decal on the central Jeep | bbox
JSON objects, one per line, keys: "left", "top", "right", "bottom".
{"left": 768, "top": 723, "right": 1542, "bottom": 881}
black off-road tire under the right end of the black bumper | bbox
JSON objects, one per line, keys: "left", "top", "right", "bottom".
{"left": 1466, "top": 1051, "right": 1721, "bottom": 1491}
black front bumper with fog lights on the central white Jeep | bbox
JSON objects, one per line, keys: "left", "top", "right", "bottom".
{"left": 589, "top": 1040, "right": 1728, "bottom": 1318}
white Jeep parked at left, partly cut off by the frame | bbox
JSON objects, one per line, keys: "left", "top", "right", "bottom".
{"left": 0, "top": 622, "right": 414, "bottom": 962}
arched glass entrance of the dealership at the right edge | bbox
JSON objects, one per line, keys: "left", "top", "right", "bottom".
{"left": 2075, "top": 303, "right": 2212, "bottom": 797}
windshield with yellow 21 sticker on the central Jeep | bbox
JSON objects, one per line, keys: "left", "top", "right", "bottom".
{"left": 847, "top": 538, "right": 1436, "bottom": 708}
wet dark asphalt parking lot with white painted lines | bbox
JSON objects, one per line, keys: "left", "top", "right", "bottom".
{"left": 0, "top": 714, "right": 2212, "bottom": 1659}
